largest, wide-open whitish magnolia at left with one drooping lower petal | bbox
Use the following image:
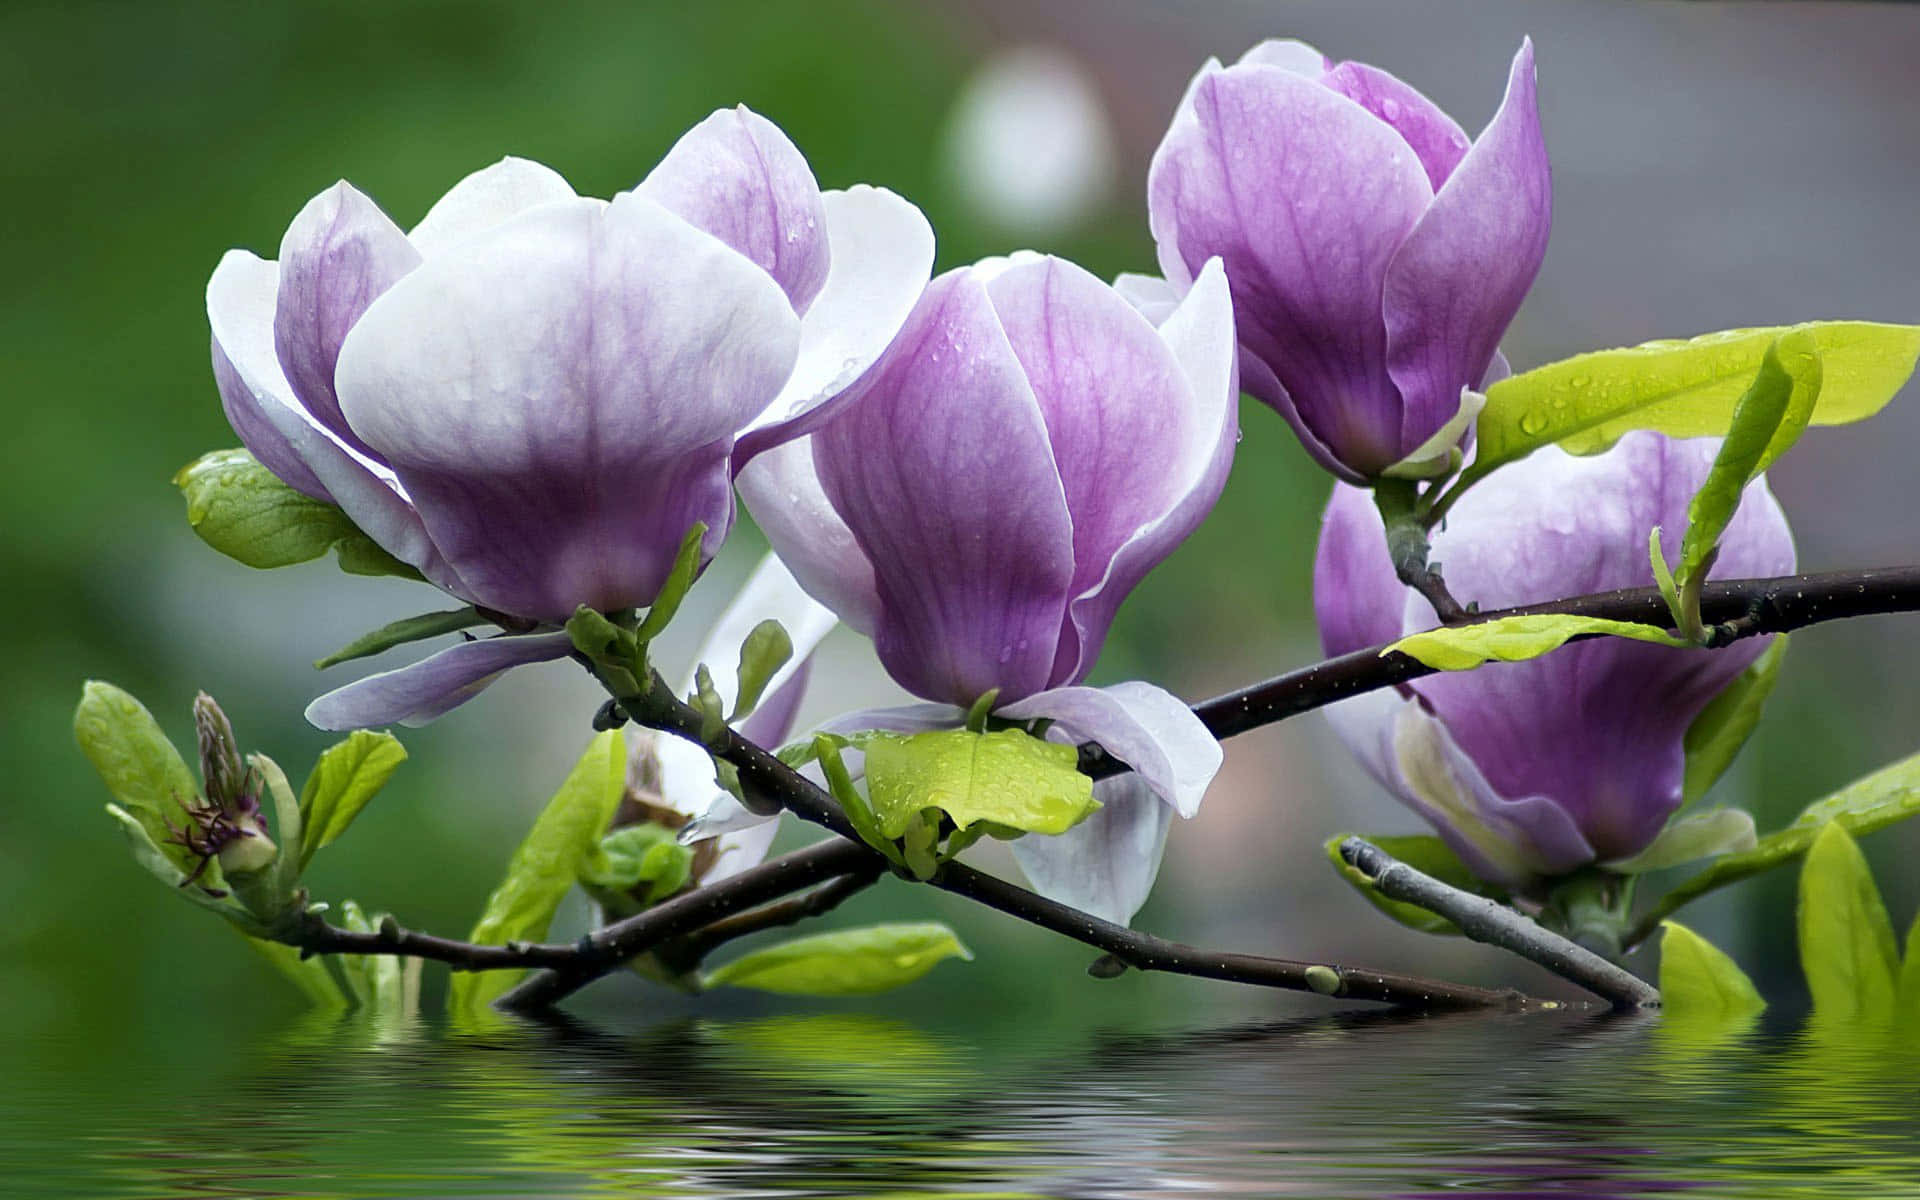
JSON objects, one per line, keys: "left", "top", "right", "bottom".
{"left": 207, "top": 108, "right": 933, "bottom": 728}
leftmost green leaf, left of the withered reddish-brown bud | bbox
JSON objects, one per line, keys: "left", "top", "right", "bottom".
{"left": 73, "top": 680, "right": 201, "bottom": 871}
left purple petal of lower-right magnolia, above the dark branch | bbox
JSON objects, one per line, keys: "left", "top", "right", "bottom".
{"left": 1313, "top": 484, "right": 1407, "bottom": 657}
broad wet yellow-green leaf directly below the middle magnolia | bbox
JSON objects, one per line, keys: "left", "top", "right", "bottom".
{"left": 866, "top": 730, "right": 1100, "bottom": 837}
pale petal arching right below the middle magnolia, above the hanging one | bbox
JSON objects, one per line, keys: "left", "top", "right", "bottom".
{"left": 995, "top": 682, "right": 1221, "bottom": 816}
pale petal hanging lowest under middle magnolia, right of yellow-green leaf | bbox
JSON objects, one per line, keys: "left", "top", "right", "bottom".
{"left": 1012, "top": 776, "right": 1173, "bottom": 925}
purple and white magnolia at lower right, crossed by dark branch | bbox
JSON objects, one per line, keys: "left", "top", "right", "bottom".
{"left": 1313, "top": 432, "right": 1793, "bottom": 889}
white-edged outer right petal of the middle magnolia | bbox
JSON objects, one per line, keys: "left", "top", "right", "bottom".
{"left": 1054, "top": 259, "right": 1240, "bottom": 682}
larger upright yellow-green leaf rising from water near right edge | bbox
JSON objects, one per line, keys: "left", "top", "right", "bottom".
{"left": 1799, "top": 822, "right": 1901, "bottom": 1025}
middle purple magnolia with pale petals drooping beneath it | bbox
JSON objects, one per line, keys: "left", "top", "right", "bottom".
{"left": 739, "top": 255, "right": 1238, "bottom": 922}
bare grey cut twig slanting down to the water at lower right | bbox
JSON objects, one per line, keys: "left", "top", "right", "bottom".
{"left": 1340, "top": 837, "right": 1661, "bottom": 1008}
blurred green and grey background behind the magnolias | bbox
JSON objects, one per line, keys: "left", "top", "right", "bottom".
{"left": 0, "top": 0, "right": 1920, "bottom": 1068}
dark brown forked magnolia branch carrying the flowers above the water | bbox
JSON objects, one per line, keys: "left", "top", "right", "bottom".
{"left": 288, "top": 566, "right": 1920, "bottom": 1010}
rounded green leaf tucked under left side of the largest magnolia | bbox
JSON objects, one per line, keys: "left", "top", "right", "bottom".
{"left": 173, "top": 449, "right": 420, "bottom": 580}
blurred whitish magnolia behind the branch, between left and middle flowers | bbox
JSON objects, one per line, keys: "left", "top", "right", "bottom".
{"left": 614, "top": 555, "right": 837, "bottom": 887}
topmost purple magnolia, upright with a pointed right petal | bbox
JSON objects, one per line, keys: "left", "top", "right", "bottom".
{"left": 1127, "top": 40, "right": 1551, "bottom": 484}
